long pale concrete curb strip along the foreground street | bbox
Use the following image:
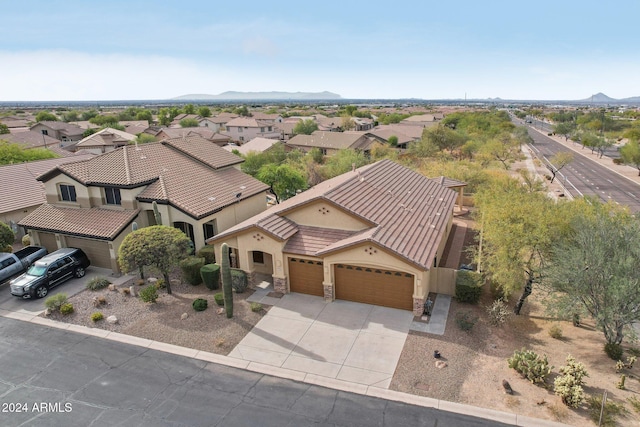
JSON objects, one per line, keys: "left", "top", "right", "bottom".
{"left": 0, "top": 309, "right": 567, "bottom": 427}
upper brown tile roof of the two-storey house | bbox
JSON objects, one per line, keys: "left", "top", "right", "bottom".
{"left": 40, "top": 136, "right": 269, "bottom": 219}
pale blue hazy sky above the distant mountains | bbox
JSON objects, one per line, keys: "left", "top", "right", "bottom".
{"left": 0, "top": 0, "right": 640, "bottom": 101}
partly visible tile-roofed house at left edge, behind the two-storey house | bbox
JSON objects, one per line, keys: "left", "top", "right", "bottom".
{"left": 0, "top": 154, "right": 93, "bottom": 240}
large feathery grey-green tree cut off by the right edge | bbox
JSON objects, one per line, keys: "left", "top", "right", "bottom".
{"left": 543, "top": 200, "right": 640, "bottom": 344}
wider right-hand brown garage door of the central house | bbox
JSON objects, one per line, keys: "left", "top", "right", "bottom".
{"left": 335, "top": 264, "right": 413, "bottom": 310}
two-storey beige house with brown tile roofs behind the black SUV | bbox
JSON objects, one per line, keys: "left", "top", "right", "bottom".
{"left": 19, "top": 136, "right": 269, "bottom": 272}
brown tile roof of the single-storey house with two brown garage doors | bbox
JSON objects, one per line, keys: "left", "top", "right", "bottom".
{"left": 209, "top": 160, "right": 457, "bottom": 269}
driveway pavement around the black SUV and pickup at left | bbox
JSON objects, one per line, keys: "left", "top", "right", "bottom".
{"left": 0, "top": 267, "right": 129, "bottom": 314}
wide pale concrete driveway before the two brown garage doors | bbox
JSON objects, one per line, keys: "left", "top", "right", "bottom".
{"left": 229, "top": 293, "right": 413, "bottom": 388}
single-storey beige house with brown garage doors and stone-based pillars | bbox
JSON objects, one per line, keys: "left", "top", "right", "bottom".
{"left": 207, "top": 160, "right": 456, "bottom": 315}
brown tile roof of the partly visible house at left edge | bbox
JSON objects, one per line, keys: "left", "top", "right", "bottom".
{"left": 0, "top": 154, "right": 94, "bottom": 213}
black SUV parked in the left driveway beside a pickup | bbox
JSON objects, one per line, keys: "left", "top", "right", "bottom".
{"left": 11, "top": 248, "right": 91, "bottom": 298}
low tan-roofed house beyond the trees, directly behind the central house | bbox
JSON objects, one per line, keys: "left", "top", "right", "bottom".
{"left": 287, "top": 130, "right": 375, "bottom": 156}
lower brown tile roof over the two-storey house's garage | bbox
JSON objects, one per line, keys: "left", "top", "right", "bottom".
{"left": 19, "top": 204, "right": 140, "bottom": 240}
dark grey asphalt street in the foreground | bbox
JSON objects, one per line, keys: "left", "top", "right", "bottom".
{"left": 0, "top": 317, "right": 506, "bottom": 427}
